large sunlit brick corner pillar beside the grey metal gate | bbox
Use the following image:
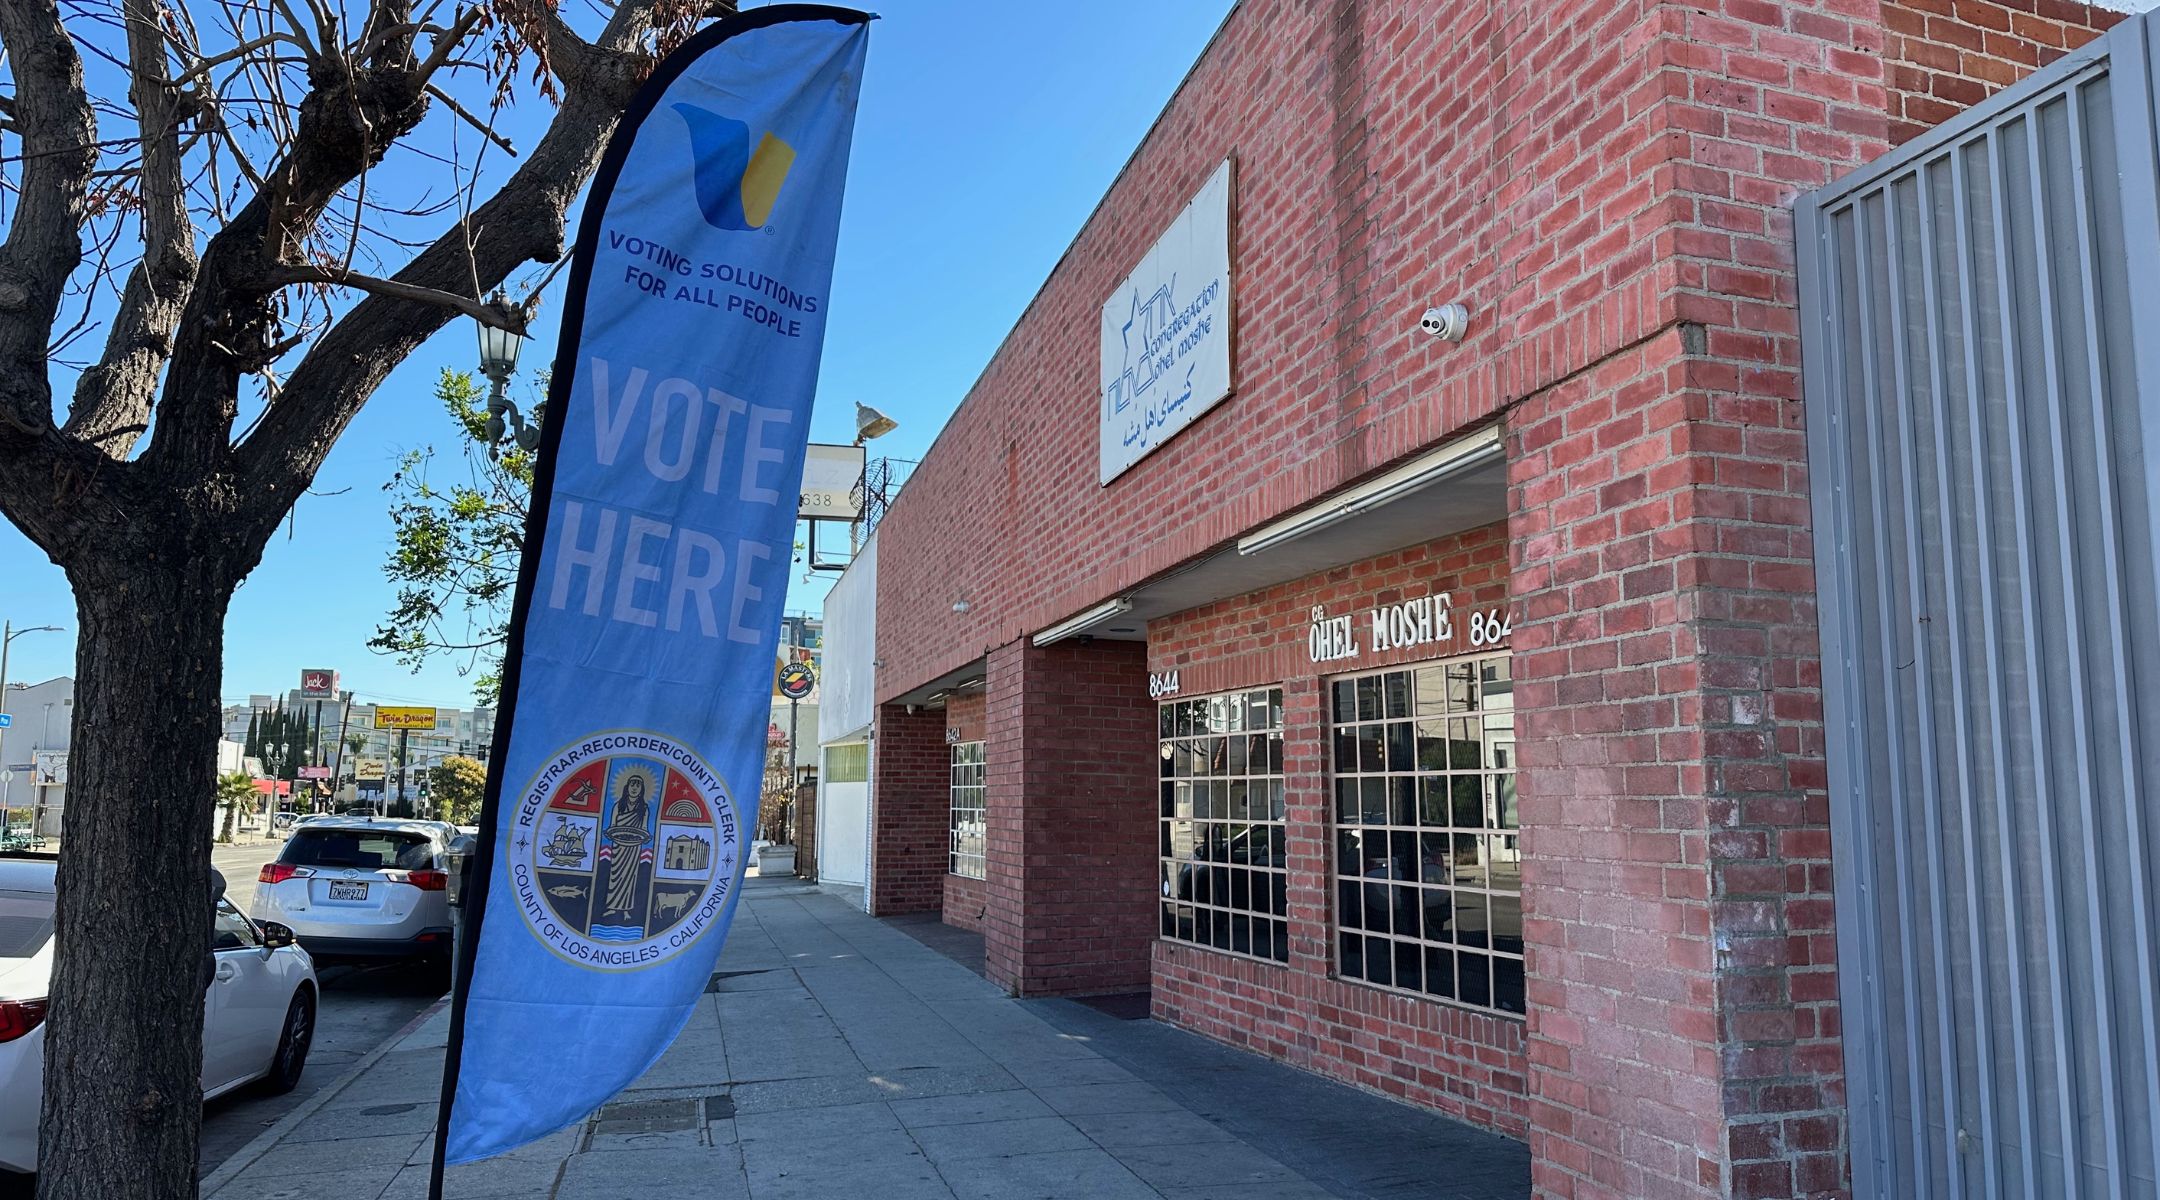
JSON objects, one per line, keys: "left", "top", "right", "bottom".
{"left": 1510, "top": 326, "right": 1845, "bottom": 1200}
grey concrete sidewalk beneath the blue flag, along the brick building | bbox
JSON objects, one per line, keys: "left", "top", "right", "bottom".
{"left": 205, "top": 878, "right": 1529, "bottom": 1200}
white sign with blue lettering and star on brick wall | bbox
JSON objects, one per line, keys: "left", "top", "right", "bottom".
{"left": 1099, "top": 162, "right": 1233, "bottom": 483}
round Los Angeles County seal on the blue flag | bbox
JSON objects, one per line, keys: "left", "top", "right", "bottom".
{"left": 510, "top": 729, "right": 741, "bottom": 971}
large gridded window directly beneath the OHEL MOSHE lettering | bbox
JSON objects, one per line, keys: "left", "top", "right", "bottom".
{"left": 1328, "top": 654, "right": 1523, "bottom": 1012}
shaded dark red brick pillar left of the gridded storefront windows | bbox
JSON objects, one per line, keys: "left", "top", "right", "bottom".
{"left": 983, "top": 641, "right": 1158, "bottom": 995}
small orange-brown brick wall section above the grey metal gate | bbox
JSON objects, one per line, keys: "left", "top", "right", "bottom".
{"left": 1884, "top": 0, "right": 2123, "bottom": 142}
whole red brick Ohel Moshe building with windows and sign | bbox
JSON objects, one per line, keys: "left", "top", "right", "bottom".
{"left": 846, "top": 0, "right": 2115, "bottom": 1200}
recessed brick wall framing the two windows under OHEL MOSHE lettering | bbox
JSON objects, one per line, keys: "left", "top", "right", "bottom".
{"left": 1147, "top": 524, "right": 1527, "bottom": 1137}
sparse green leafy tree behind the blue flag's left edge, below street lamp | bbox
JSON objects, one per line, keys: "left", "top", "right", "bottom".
{"left": 367, "top": 371, "right": 546, "bottom": 704}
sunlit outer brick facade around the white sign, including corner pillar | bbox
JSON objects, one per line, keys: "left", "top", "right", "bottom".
{"left": 859, "top": 0, "right": 2112, "bottom": 1200}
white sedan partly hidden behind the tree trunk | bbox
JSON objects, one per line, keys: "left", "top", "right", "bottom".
{"left": 0, "top": 857, "right": 320, "bottom": 1172}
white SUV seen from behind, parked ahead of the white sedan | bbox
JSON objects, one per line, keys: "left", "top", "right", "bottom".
{"left": 253, "top": 816, "right": 451, "bottom": 960}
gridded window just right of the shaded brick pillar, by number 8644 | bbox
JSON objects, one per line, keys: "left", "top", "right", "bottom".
{"left": 1158, "top": 688, "right": 1290, "bottom": 963}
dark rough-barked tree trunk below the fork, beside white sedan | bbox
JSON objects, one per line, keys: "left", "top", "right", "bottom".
{"left": 37, "top": 550, "right": 238, "bottom": 1200}
